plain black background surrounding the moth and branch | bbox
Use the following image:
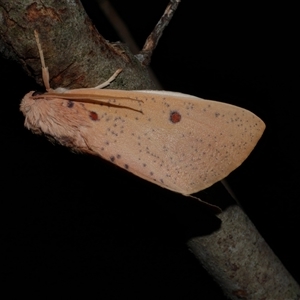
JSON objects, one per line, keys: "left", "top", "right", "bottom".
{"left": 0, "top": 0, "right": 300, "bottom": 299}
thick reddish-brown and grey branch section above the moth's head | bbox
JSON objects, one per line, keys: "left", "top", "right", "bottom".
{"left": 0, "top": 0, "right": 154, "bottom": 89}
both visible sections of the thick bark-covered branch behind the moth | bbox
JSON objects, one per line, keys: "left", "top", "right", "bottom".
{"left": 0, "top": 0, "right": 300, "bottom": 300}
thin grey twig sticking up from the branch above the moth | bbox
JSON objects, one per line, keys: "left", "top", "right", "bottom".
{"left": 138, "top": 0, "right": 180, "bottom": 66}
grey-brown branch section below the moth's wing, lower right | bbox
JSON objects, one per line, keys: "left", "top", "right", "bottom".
{"left": 188, "top": 206, "right": 300, "bottom": 300}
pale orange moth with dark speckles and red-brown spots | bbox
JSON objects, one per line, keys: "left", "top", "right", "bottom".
{"left": 20, "top": 32, "right": 265, "bottom": 203}
